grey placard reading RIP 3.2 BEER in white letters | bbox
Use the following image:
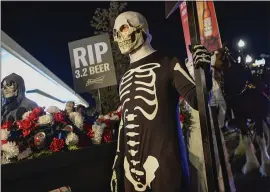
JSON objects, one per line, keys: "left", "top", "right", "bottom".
{"left": 69, "top": 34, "right": 117, "bottom": 92}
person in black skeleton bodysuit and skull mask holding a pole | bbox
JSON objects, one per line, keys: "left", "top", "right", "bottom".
{"left": 111, "top": 12, "right": 210, "bottom": 192}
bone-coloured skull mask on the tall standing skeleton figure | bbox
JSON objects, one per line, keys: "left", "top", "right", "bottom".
{"left": 113, "top": 11, "right": 151, "bottom": 54}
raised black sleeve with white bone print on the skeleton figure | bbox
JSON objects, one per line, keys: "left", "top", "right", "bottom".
{"left": 169, "top": 57, "right": 198, "bottom": 110}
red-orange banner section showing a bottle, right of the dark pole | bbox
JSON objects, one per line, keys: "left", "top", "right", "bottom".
{"left": 196, "top": 0, "right": 222, "bottom": 52}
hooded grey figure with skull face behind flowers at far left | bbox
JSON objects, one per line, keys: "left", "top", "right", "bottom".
{"left": 1, "top": 73, "right": 37, "bottom": 122}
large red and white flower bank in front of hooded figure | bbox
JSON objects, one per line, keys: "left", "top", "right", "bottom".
{"left": 1, "top": 107, "right": 91, "bottom": 164}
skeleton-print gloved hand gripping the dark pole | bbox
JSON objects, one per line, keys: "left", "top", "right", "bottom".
{"left": 190, "top": 45, "right": 211, "bottom": 68}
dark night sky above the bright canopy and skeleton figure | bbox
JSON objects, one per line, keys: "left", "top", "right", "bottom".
{"left": 1, "top": 1, "right": 270, "bottom": 87}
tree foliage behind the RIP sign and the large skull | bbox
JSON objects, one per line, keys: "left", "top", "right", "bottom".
{"left": 91, "top": 1, "right": 129, "bottom": 114}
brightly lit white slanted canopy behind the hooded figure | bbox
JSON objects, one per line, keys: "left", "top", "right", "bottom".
{"left": 1, "top": 31, "right": 88, "bottom": 109}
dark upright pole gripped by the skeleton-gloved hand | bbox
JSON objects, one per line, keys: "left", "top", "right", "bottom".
{"left": 187, "top": 1, "right": 220, "bottom": 192}
